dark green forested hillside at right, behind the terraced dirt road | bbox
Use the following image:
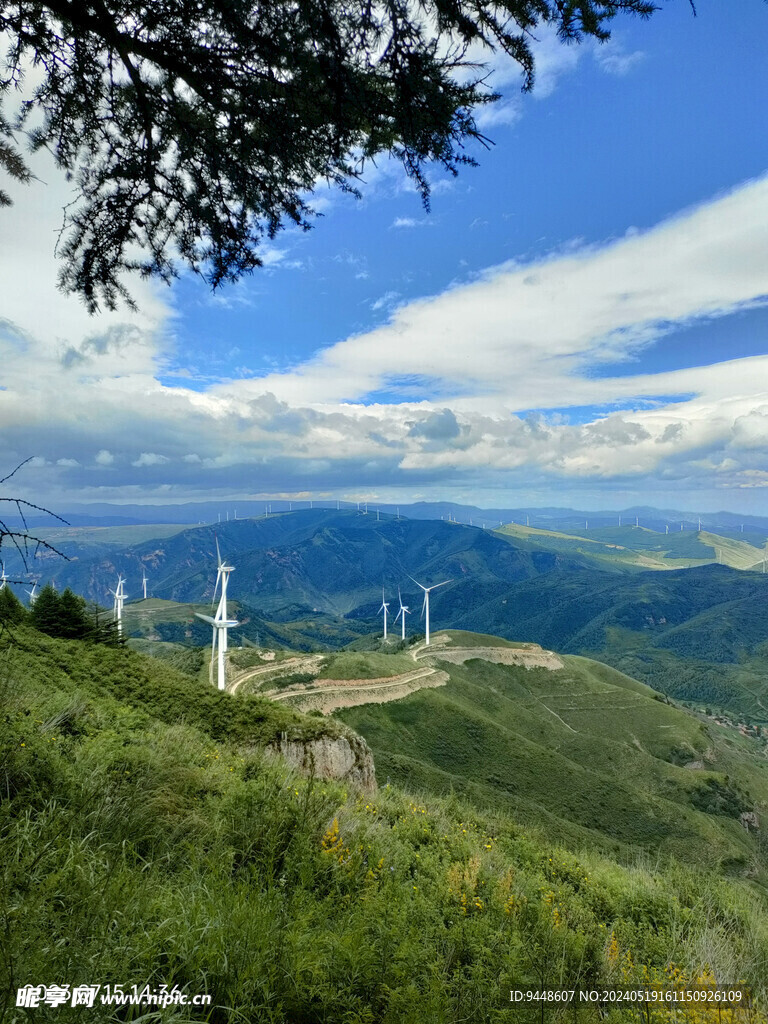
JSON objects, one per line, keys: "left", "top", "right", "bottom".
{"left": 454, "top": 564, "right": 768, "bottom": 725}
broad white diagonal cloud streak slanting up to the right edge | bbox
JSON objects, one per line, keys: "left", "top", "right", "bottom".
{"left": 233, "top": 177, "right": 768, "bottom": 411}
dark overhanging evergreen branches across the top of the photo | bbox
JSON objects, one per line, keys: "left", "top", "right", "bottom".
{"left": 0, "top": 0, "right": 657, "bottom": 310}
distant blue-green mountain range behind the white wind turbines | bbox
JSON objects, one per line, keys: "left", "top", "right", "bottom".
{"left": 15, "top": 509, "right": 768, "bottom": 723}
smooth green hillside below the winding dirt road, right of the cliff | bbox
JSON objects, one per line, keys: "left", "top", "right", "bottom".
{"left": 337, "top": 633, "right": 768, "bottom": 881}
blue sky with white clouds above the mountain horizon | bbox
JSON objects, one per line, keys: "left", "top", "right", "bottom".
{"left": 0, "top": 0, "right": 768, "bottom": 515}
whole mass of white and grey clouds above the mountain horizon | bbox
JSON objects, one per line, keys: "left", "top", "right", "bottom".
{"left": 0, "top": 168, "right": 768, "bottom": 506}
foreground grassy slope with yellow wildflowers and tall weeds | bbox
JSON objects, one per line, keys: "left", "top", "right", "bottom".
{"left": 0, "top": 631, "right": 768, "bottom": 1024}
